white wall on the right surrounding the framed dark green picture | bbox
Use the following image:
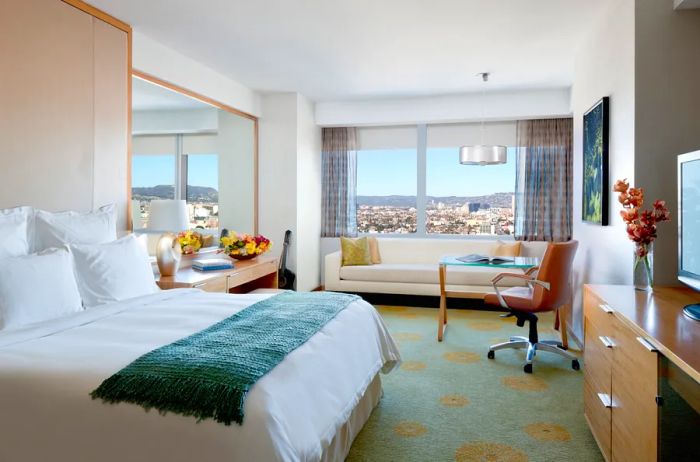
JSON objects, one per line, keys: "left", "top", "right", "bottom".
{"left": 571, "top": 0, "right": 636, "bottom": 340}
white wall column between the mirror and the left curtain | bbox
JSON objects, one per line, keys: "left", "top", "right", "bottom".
{"left": 258, "top": 93, "right": 321, "bottom": 290}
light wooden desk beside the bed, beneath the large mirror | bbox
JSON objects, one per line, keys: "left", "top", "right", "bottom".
{"left": 158, "top": 255, "right": 279, "bottom": 293}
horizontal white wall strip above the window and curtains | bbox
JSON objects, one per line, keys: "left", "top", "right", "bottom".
{"left": 316, "top": 88, "right": 571, "bottom": 127}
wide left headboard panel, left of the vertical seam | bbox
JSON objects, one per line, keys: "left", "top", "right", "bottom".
{"left": 0, "top": 0, "right": 93, "bottom": 210}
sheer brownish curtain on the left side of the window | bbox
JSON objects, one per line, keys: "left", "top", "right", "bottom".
{"left": 321, "top": 127, "right": 357, "bottom": 237}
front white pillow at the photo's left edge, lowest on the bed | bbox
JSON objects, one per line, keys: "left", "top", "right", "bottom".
{"left": 0, "top": 246, "right": 83, "bottom": 330}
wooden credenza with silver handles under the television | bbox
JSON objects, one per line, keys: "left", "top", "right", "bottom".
{"left": 584, "top": 285, "right": 700, "bottom": 462}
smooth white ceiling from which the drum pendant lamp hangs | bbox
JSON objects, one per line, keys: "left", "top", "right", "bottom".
{"left": 90, "top": 0, "right": 612, "bottom": 101}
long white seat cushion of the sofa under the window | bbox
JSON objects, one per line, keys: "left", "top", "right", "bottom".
{"left": 340, "top": 263, "right": 523, "bottom": 287}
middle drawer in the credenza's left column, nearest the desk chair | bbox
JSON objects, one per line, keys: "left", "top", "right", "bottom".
{"left": 583, "top": 318, "right": 615, "bottom": 395}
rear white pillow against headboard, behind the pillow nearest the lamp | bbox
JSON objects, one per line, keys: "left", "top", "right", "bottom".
{"left": 34, "top": 204, "right": 117, "bottom": 250}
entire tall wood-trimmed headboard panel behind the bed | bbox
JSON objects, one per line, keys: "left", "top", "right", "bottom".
{"left": 0, "top": 0, "right": 131, "bottom": 230}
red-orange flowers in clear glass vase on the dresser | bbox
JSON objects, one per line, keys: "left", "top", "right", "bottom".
{"left": 613, "top": 178, "right": 671, "bottom": 285}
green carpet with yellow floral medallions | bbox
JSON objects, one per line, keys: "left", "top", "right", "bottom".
{"left": 347, "top": 306, "right": 603, "bottom": 462}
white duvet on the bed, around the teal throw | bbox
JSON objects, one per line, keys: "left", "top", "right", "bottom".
{"left": 0, "top": 289, "right": 399, "bottom": 462}
